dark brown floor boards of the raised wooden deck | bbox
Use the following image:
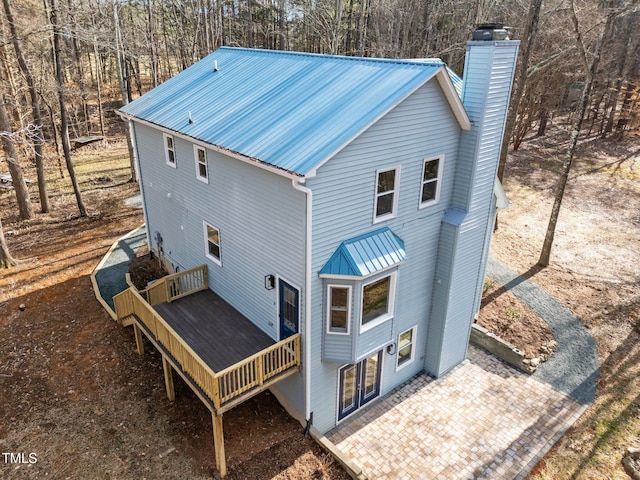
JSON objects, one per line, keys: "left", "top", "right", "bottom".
{"left": 154, "top": 289, "right": 276, "bottom": 373}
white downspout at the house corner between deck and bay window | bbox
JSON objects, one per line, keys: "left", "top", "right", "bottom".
{"left": 291, "top": 178, "right": 313, "bottom": 433}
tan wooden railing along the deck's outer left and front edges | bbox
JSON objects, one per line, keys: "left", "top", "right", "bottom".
{"left": 113, "top": 282, "right": 301, "bottom": 410}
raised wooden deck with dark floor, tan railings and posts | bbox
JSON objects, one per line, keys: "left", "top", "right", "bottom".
{"left": 113, "top": 265, "right": 301, "bottom": 478}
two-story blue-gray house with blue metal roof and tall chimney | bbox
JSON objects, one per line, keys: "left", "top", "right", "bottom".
{"left": 120, "top": 24, "right": 519, "bottom": 474}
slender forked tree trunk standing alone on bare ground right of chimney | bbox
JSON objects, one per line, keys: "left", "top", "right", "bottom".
{"left": 538, "top": 1, "right": 616, "bottom": 267}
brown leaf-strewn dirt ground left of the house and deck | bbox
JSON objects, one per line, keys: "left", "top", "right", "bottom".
{"left": 0, "top": 141, "right": 349, "bottom": 480}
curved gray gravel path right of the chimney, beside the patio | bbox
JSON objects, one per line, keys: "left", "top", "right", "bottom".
{"left": 487, "top": 259, "right": 599, "bottom": 405}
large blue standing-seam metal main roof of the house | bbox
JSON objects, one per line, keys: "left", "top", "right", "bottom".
{"left": 120, "top": 47, "right": 456, "bottom": 175}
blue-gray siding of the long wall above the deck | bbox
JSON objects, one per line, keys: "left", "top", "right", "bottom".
{"left": 131, "top": 124, "right": 305, "bottom": 340}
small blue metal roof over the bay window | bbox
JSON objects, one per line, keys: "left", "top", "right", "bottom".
{"left": 318, "top": 227, "right": 407, "bottom": 277}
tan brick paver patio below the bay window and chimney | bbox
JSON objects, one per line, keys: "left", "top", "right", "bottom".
{"left": 326, "top": 346, "right": 585, "bottom": 480}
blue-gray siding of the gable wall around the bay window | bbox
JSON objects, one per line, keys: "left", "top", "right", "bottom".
{"left": 307, "top": 81, "right": 460, "bottom": 432}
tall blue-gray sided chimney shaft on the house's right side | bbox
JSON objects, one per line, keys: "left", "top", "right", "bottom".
{"left": 425, "top": 40, "right": 520, "bottom": 377}
